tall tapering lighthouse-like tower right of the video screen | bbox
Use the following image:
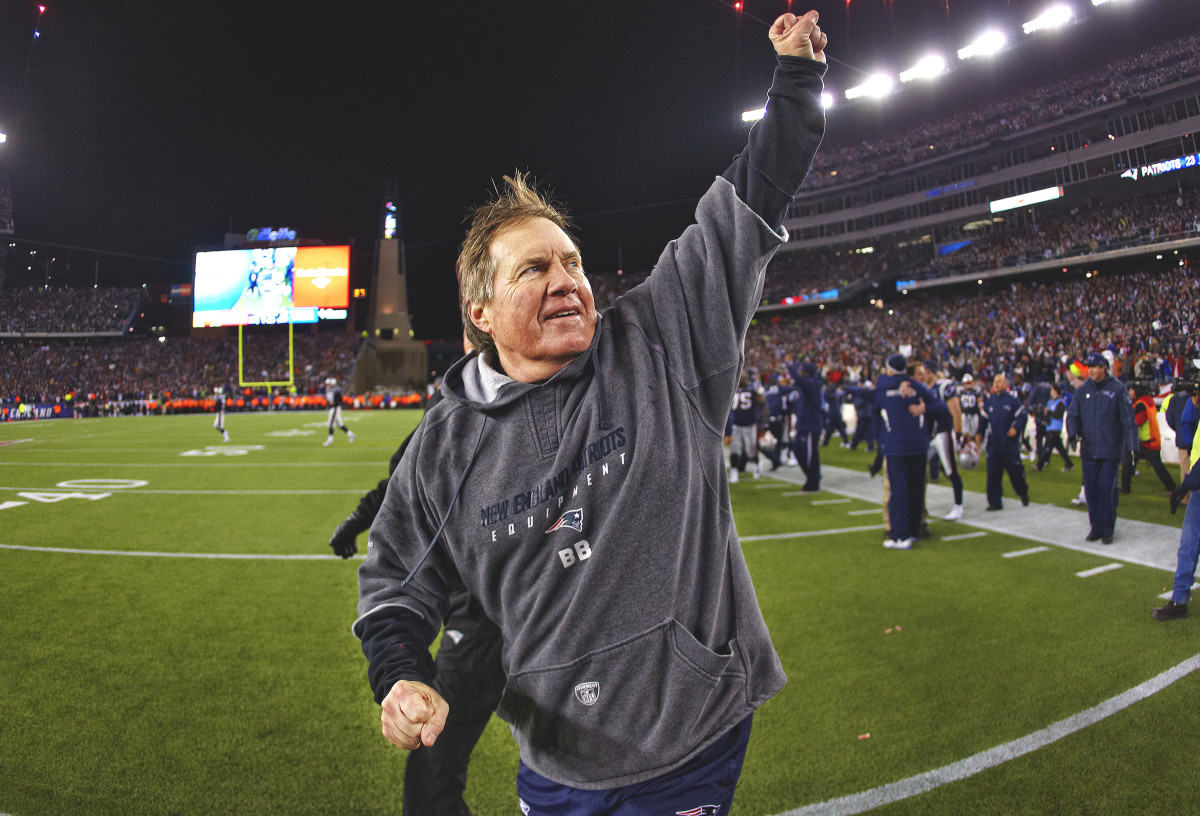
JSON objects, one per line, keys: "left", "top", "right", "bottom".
{"left": 353, "top": 179, "right": 428, "bottom": 394}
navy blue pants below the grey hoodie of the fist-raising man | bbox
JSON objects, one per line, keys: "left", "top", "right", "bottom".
{"left": 517, "top": 715, "right": 754, "bottom": 816}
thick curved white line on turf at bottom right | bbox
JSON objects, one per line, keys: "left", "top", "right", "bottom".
{"left": 778, "top": 654, "right": 1200, "bottom": 816}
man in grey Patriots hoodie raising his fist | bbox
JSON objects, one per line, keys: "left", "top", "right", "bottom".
{"left": 354, "top": 12, "right": 826, "bottom": 816}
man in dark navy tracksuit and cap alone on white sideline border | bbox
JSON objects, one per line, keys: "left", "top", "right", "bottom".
{"left": 1067, "top": 352, "right": 1138, "bottom": 544}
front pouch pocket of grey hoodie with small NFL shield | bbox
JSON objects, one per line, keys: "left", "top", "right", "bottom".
{"left": 498, "top": 618, "right": 745, "bottom": 785}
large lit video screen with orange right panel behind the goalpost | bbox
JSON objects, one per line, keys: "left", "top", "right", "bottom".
{"left": 192, "top": 246, "right": 350, "bottom": 328}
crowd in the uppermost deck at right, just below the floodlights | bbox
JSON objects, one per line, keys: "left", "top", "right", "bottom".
{"left": 802, "top": 27, "right": 1200, "bottom": 190}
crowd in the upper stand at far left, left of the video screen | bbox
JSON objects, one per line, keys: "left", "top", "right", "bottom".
{"left": 0, "top": 287, "right": 143, "bottom": 335}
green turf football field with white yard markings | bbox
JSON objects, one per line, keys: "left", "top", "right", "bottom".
{"left": 0, "top": 412, "right": 1200, "bottom": 816}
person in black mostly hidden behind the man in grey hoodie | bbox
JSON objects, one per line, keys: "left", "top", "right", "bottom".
{"left": 329, "top": 343, "right": 504, "bottom": 816}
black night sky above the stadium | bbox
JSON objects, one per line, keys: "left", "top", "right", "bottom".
{"left": 0, "top": 0, "right": 1200, "bottom": 337}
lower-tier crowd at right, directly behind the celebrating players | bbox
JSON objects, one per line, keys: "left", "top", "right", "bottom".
{"left": 745, "top": 265, "right": 1200, "bottom": 382}
